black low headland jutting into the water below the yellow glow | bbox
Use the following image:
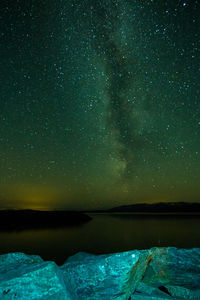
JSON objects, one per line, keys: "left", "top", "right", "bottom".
{"left": 0, "top": 209, "right": 92, "bottom": 231}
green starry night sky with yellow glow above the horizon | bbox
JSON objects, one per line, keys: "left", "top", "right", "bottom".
{"left": 0, "top": 0, "right": 200, "bottom": 210}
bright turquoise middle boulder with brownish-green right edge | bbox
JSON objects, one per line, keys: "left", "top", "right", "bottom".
{"left": 61, "top": 250, "right": 151, "bottom": 300}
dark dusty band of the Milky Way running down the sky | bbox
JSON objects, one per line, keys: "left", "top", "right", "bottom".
{"left": 84, "top": 1, "right": 142, "bottom": 175}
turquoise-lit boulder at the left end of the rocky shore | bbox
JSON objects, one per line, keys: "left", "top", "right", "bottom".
{"left": 0, "top": 253, "right": 72, "bottom": 300}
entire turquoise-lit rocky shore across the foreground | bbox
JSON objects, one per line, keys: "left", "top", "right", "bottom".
{"left": 0, "top": 247, "right": 200, "bottom": 300}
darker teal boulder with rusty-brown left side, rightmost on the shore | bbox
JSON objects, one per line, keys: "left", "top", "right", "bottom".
{"left": 143, "top": 247, "right": 200, "bottom": 289}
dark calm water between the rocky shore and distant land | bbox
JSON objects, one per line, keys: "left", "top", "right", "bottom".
{"left": 0, "top": 214, "right": 200, "bottom": 265}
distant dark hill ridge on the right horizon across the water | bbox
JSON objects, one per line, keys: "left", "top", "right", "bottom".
{"left": 107, "top": 202, "right": 200, "bottom": 213}
